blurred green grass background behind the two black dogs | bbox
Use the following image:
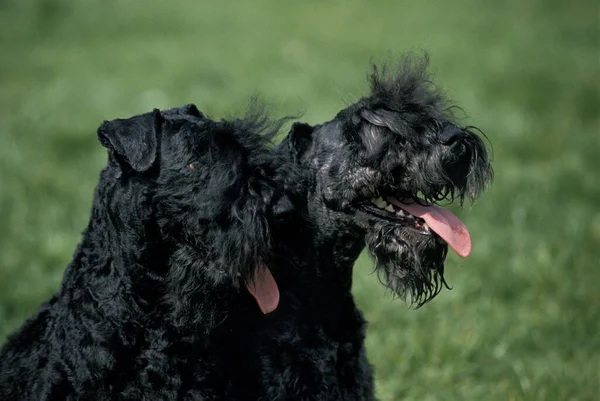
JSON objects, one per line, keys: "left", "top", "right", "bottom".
{"left": 0, "top": 0, "right": 600, "bottom": 401}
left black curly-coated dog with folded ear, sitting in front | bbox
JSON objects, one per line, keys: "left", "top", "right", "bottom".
{"left": 0, "top": 105, "right": 296, "bottom": 401}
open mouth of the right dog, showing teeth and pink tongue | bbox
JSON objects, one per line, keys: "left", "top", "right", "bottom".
{"left": 361, "top": 196, "right": 471, "bottom": 257}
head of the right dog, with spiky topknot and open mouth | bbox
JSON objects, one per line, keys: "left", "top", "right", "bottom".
{"left": 282, "top": 59, "right": 493, "bottom": 304}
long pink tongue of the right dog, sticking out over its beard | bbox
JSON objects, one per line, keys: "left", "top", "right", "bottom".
{"left": 387, "top": 197, "right": 471, "bottom": 258}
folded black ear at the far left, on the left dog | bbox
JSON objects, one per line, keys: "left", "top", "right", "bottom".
{"left": 98, "top": 109, "right": 162, "bottom": 172}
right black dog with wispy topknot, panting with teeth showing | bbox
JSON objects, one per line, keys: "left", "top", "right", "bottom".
{"left": 274, "top": 54, "right": 493, "bottom": 400}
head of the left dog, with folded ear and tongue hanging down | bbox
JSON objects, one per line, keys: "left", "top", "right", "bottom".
{"left": 98, "top": 105, "right": 278, "bottom": 312}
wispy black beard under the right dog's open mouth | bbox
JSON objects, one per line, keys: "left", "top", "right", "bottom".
{"left": 367, "top": 228, "right": 450, "bottom": 308}
